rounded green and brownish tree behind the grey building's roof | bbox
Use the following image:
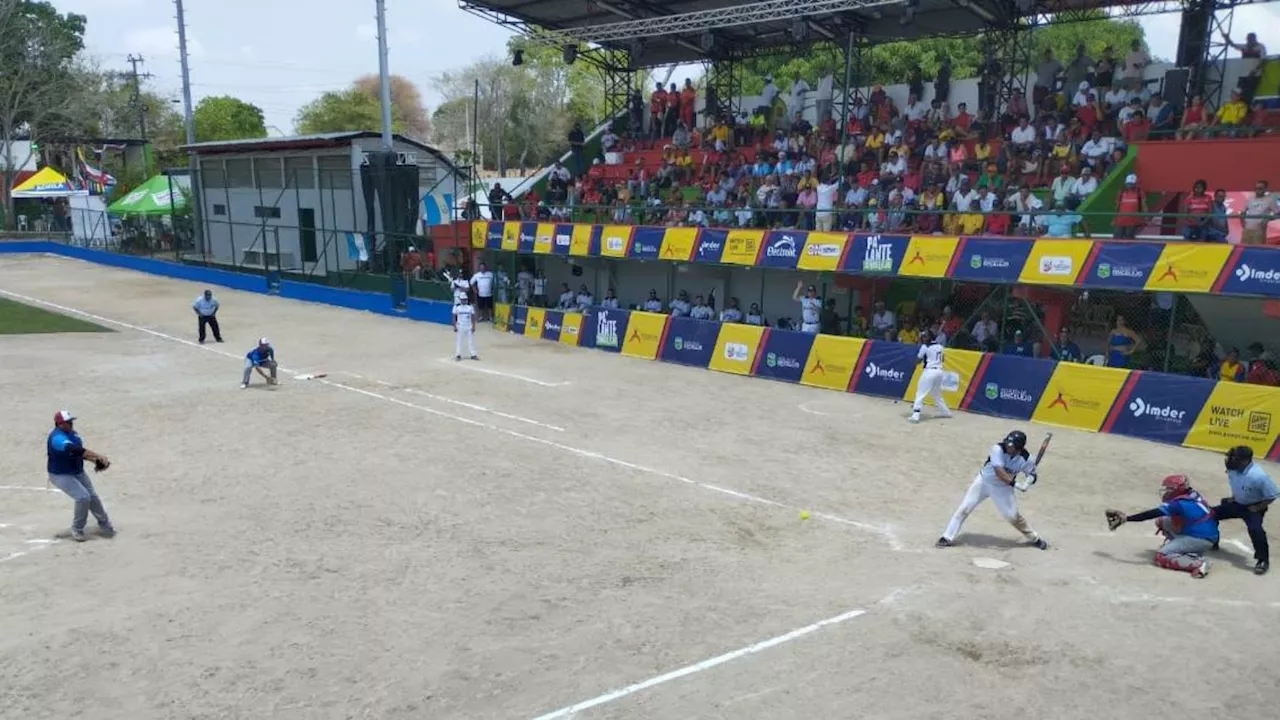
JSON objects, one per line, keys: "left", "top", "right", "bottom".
{"left": 293, "top": 76, "right": 430, "bottom": 140}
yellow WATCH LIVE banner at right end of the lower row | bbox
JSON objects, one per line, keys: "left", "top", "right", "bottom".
{"left": 1183, "top": 382, "right": 1280, "bottom": 448}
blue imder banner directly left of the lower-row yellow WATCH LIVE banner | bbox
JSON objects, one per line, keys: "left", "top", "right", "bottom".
{"left": 1102, "top": 372, "right": 1215, "bottom": 445}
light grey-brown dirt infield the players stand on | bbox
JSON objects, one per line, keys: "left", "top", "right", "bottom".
{"left": 0, "top": 256, "right": 1280, "bottom": 720}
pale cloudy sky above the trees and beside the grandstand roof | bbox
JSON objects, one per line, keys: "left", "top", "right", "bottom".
{"left": 52, "top": 0, "right": 1280, "bottom": 135}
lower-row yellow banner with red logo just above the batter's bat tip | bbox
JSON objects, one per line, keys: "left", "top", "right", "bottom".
{"left": 1032, "top": 363, "right": 1129, "bottom": 432}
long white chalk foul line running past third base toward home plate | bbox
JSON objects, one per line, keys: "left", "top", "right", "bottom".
{"left": 0, "top": 283, "right": 908, "bottom": 551}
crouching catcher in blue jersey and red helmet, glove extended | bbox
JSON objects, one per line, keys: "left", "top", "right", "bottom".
{"left": 1106, "top": 475, "right": 1219, "bottom": 578}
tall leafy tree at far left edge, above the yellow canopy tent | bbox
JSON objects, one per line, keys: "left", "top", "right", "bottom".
{"left": 0, "top": 0, "right": 84, "bottom": 223}
